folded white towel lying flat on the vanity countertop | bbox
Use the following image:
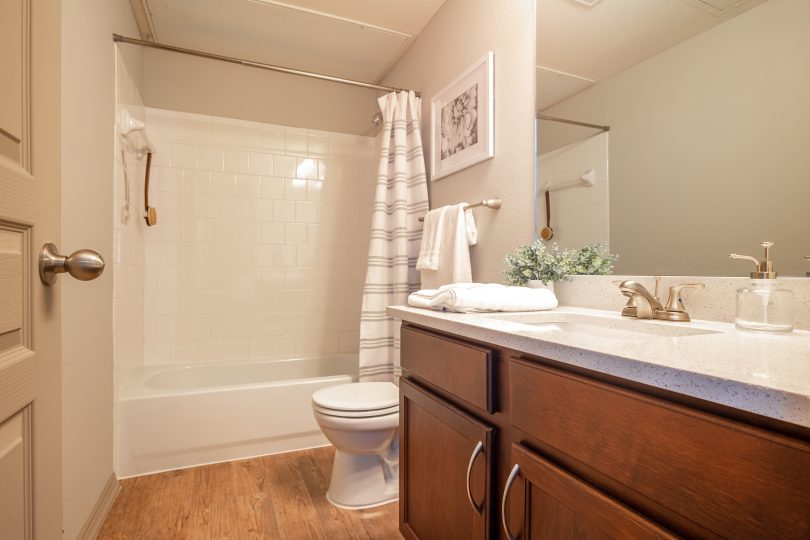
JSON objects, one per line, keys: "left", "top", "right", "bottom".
{"left": 408, "top": 283, "right": 557, "bottom": 313}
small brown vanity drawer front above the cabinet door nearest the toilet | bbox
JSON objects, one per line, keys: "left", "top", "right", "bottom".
{"left": 401, "top": 326, "right": 495, "bottom": 413}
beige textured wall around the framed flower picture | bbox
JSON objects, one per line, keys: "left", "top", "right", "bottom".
{"left": 384, "top": 0, "right": 535, "bottom": 282}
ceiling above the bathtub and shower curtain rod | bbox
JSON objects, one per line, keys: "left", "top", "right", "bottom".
{"left": 137, "top": 0, "right": 444, "bottom": 83}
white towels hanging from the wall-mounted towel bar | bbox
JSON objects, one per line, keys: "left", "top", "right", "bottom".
{"left": 416, "top": 203, "right": 477, "bottom": 289}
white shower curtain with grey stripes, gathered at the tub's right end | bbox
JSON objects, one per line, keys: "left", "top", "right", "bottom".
{"left": 360, "top": 91, "right": 428, "bottom": 381}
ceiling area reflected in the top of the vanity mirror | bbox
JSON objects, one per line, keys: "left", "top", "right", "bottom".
{"left": 536, "top": 0, "right": 766, "bottom": 110}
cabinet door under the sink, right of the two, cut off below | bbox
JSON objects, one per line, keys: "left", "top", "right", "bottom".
{"left": 502, "top": 444, "right": 677, "bottom": 540}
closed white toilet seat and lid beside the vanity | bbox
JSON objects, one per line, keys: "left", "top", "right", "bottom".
{"left": 312, "top": 382, "right": 399, "bottom": 418}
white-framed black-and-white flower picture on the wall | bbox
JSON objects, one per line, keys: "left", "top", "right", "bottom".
{"left": 430, "top": 51, "right": 495, "bottom": 180}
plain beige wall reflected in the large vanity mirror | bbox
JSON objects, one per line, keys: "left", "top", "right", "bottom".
{"left": 546, "top": 0, "right": 810, "bottom": 276}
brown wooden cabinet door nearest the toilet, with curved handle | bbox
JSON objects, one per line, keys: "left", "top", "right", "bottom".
{"left": 400, "top": 379, "right": 494, "bottom": 540}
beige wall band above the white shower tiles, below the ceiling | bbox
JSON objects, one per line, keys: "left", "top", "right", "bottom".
{"left": 139, "top": 49, "right": 378, "bottom": 135}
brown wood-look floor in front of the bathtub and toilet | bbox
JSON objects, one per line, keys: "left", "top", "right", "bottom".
{"left": 98, "top": 447, "right": 402, "bottom": 540}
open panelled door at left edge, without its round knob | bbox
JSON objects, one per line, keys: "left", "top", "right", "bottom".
{"left": 0, "top": 0, "right": 62, "bottom": 540}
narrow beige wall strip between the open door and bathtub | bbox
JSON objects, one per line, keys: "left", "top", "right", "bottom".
{"left": 59, "top": 0, "right": 137, "bottom": 538}
